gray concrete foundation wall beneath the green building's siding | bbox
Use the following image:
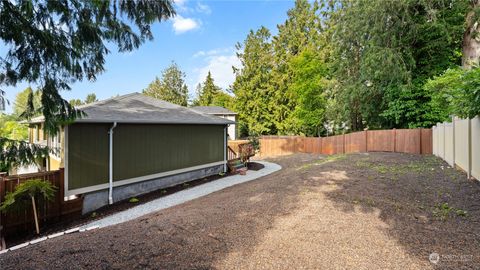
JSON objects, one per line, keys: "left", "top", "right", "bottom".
{"left": 82, "top": 165, "right": 223, "bottom": 214}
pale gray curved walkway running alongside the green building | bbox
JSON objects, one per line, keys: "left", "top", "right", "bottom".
{"left": 80, "top": 161, "right": 282, "bottom": 229}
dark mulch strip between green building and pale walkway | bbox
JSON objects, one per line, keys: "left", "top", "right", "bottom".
{"left": 0, "top": 162, "right": 264, "bottom": 249}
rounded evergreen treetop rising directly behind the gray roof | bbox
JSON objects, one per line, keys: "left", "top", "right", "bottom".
{"left": 143, "top": 62, "right": 188, "bottom": 106}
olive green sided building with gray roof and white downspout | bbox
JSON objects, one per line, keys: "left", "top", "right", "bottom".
{"left": 37, "top": 93, "right": 234, "bottom": 212}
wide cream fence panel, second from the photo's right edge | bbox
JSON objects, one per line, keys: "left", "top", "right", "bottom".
{"left": 454, "top": 119, "right": 470, "bottom": 171}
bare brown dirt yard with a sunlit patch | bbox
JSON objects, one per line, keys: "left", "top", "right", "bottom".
{"left": 0, "top": 153, "right": 480, "bottom": 270}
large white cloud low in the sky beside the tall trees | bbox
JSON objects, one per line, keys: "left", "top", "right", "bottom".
{"left": 194, "top": 53, "right": 241, "bottom": 89}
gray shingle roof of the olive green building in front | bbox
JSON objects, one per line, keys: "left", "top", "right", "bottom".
{"left": 31, "top": 93, "right": 235, "bottom": 125}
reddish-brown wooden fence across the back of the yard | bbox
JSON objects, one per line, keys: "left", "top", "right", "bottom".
{"left": 260, "top": 128, "right": 432, "bottom": 157}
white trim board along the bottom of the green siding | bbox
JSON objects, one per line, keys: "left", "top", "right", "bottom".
{"left": 65, "top": 160, "right": 226, "bottom": 197}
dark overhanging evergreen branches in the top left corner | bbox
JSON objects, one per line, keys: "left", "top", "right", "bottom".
{"left": 0, "top": 0, "right": 175, "bottom": 133}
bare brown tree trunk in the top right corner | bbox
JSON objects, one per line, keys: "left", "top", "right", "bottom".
{"left": 462, "top": 0, "right": 480, "bottom": 69}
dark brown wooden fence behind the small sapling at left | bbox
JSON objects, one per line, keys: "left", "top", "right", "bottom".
{"left": 0, "top": 169, "right": 83, "bottom": 236}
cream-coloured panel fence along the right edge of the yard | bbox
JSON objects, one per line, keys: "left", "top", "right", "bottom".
{"left": 433, "top": 116, "right": 480, "bottom": 180}
